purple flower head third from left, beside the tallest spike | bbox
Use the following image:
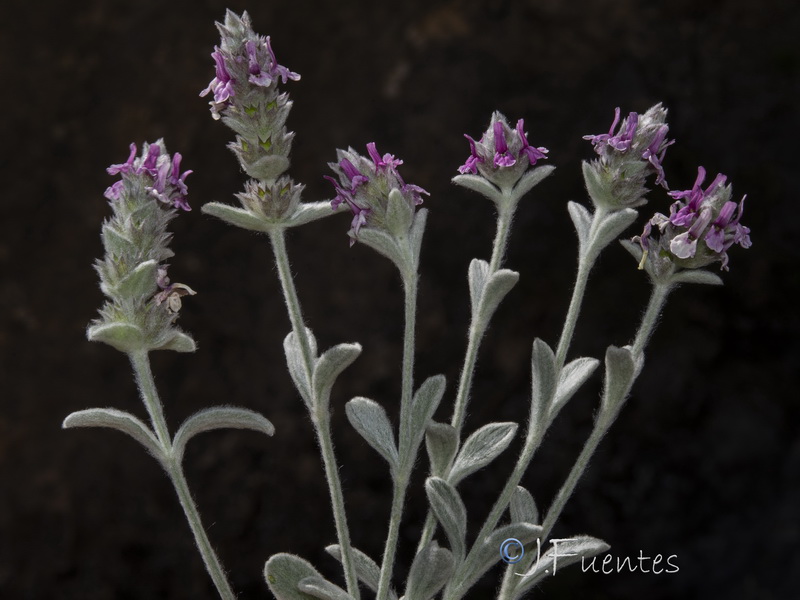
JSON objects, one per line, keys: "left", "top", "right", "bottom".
{"left": 325, "top": 142, "right": 429, "bottom": 246}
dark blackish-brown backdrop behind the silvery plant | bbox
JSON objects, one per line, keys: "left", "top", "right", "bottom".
{"left": 0, "top": 0, "right": 800, "bottom": 600}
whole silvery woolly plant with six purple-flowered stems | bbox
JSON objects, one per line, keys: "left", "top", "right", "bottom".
{"left": 64, "top": 11, "right": 750, "bottom": 600}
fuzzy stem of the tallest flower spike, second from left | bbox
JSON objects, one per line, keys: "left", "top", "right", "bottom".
{"left": 269, "top": 229, "right": 360, "bottom": 600}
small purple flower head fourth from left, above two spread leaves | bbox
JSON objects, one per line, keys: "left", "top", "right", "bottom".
{"left": 458, "top": 112, "right": 548, "bottom": 185}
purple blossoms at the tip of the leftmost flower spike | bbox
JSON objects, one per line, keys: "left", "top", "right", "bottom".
{"left": 104, "top": 142, "right": 192, "bottom": 211}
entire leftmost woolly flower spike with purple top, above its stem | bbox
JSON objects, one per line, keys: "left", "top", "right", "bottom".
{"left": 87, "top": 140, "right": 194, "bottom": 352}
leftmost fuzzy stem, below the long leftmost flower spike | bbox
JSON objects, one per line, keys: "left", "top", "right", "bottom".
{"left": 130, "top": 350, "right": 236, "bottom": 600}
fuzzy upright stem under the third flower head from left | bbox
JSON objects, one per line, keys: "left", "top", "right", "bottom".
{"left": 375, "top": 259, "right": 418, "bottom": 600}
